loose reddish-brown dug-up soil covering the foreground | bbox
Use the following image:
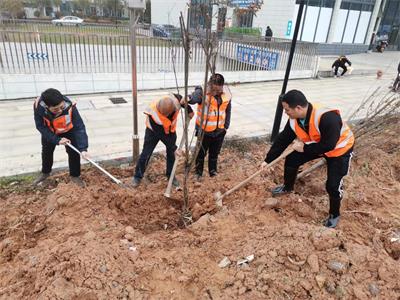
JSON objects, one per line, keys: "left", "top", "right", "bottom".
{"left": 0, "top": 125, "right": 400, "bottom": 299}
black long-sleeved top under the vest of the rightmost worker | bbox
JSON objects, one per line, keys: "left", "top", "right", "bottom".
{"left": 265, "top": 103, "right": 343, "bottom": 163}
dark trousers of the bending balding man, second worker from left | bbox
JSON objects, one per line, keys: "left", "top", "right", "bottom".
{"left": 134, "top": 128, "right": 178, "bottom": 179}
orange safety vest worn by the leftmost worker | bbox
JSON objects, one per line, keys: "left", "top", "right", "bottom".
{"left": 35, "top": 98, "right": 76, "bottom": 135}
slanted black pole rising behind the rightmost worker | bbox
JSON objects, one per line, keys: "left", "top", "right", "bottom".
{"left": 271, "top": 0, "right": 305, "bottom": 142}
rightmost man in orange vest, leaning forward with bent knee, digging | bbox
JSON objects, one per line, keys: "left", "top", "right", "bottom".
{"left": 262, "top": 90, "right": 354, "bottom": 228}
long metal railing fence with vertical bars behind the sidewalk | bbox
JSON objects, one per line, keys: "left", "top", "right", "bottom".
{"left": 0, "top": 28, "right": 317, "bottom": 74}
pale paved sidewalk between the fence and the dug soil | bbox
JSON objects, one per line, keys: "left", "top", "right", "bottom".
{"left": 0, "top": 72, "right": 395, "bottom": 176}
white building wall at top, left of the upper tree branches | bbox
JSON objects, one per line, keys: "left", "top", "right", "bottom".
{"left": 151, "top": 0, "right": 188, "bottom": 27}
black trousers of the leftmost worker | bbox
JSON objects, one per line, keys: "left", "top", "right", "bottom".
{"left": 42, "top": 132, "right": 81, "bottom": 177}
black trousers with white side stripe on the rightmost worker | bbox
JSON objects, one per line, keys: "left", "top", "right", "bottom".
{"left": 285, "top": 149, "right": 353, "bottom": 216}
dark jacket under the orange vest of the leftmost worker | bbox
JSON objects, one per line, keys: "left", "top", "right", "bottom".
{"left": 33, "top": 96, "right": 88, "bottom": 152}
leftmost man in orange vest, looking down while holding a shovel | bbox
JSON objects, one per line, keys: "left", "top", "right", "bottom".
{"left": 33, "top": 89, "right": 88, "bottom": 187}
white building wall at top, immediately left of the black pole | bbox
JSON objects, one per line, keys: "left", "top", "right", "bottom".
{"left": 253, "top": 0, "right": 296, "bottom": 38}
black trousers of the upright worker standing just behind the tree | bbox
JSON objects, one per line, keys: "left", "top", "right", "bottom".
{"left": 196, "top": 131, "right": 226, "bottom": 176}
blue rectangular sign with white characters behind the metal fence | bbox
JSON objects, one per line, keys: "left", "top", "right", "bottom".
{"left": 236, "top": 45, "right": 279, "bottom": 70}
